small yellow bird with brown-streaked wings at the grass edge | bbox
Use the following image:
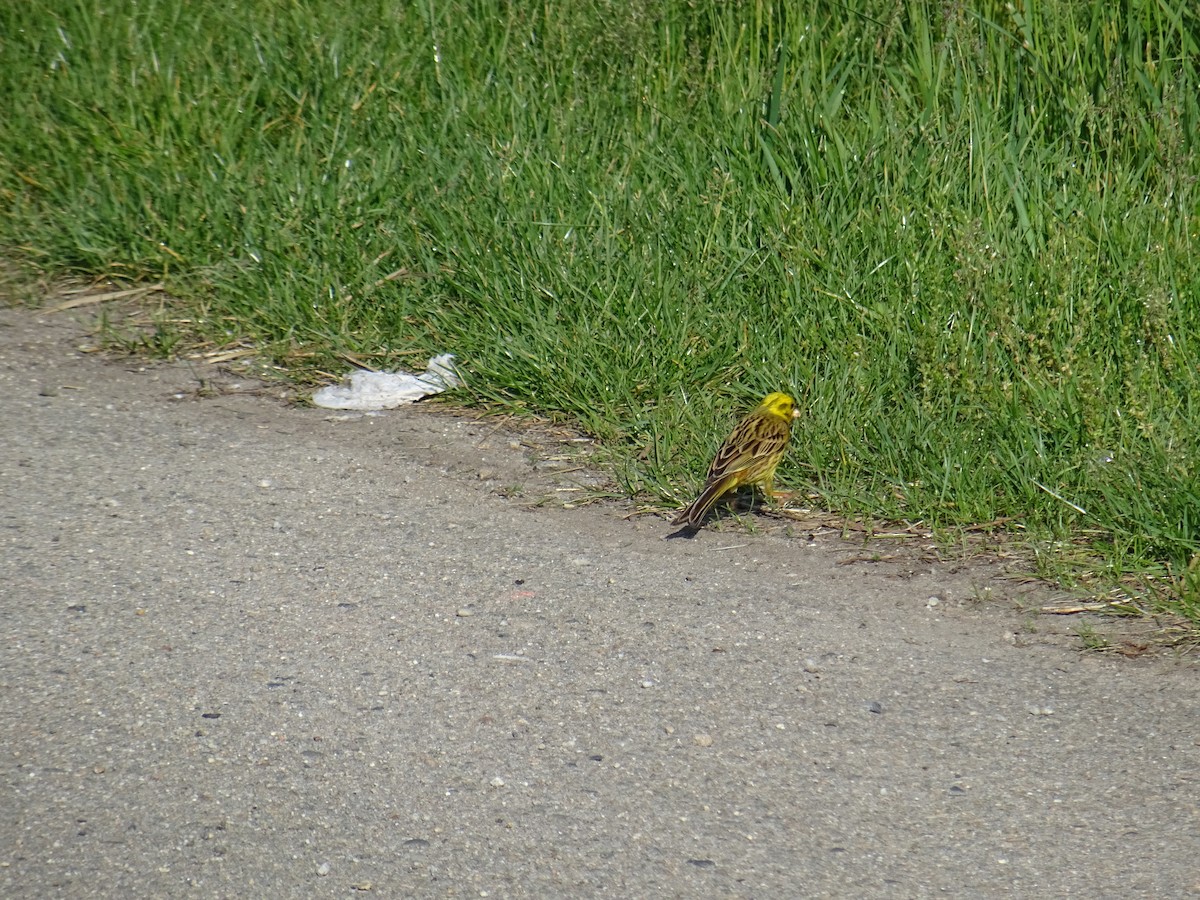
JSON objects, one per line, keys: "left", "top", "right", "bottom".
{"left": 671, "top": 391, "right": 800, "bottom": 528}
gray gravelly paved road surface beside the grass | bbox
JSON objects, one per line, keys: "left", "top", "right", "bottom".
{"left": 0, "top": 308, "right": 1200, "bottom": 898}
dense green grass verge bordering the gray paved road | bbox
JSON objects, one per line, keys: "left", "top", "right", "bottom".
{"left": 0, "top": 0, "right": 1200, "bottom": 622}
